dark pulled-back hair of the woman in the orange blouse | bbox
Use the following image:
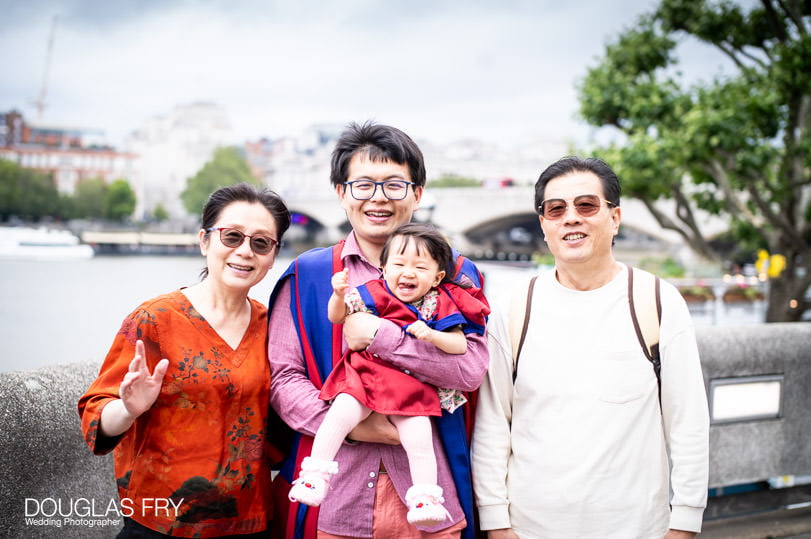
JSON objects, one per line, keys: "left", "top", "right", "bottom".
{"left": 200, "top": 182, "right": 290, "bottom": 278}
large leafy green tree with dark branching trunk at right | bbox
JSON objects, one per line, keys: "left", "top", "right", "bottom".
{"left": 578, "top": 0, "right": 811, "bottom": 322}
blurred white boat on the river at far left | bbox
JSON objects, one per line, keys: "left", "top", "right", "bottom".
{"left": 0, "top": 227, "right": 94, "bottom": 260}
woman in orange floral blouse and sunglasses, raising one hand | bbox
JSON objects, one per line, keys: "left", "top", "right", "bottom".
{"left": 79, "top": 184, "right": 290, "bottom": 538}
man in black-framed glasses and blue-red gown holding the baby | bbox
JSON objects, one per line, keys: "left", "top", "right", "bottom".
{"left": 268, "top": 123, "right": 488, "bottom": 539}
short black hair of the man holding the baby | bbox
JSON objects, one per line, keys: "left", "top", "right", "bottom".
{"left": 329, "top": 121, "right": 425, "bottom": 187}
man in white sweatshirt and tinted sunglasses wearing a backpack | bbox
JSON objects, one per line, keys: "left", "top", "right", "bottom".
{"left": 472, "top": 157, "right": 709, "bottom": 539}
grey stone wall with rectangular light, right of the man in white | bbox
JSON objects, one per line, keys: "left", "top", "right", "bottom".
{"left": 697, "top": 322, "right": 811, "bottom": 488}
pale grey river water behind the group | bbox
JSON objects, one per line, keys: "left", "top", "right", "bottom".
{"left": 0, "top": 256, "right": 759, "bottom": 371}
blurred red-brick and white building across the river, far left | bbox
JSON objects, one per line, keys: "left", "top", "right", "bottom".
{"left": 0, "top": 111, "right": 138, "bottom": 194}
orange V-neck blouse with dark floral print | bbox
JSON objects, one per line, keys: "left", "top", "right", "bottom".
{"left": 79, "top": 290, "right": 276, "bottom": 537}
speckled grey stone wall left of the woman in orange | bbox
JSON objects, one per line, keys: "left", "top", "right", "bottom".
{"left": 0, "top": 363, "right": 115, "bottom": 539}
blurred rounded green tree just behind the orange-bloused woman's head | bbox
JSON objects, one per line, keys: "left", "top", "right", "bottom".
{"left": 180, "top": 147, "right": 261, "bottom": 215}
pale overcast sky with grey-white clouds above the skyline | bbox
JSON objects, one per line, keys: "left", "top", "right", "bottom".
{"left": 0, "top": 0, "right": 736, "bottom": 149}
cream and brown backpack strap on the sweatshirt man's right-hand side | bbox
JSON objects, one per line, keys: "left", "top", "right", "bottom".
{"left": 628, "top": 267, "right": 662, "bottom": 406}
